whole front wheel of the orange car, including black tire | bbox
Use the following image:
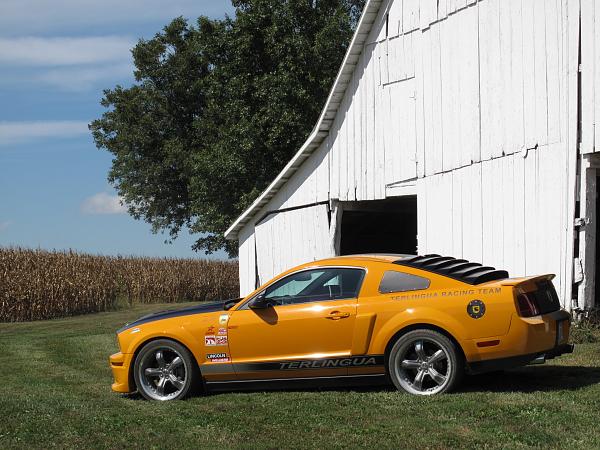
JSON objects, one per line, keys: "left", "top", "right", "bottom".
{"left": 133, "top": 339, "right": 201, "bottom": 401}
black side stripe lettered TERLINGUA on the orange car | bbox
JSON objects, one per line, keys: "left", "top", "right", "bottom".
{"left": 233, "top": 355, "right": 385, "bottom": 373}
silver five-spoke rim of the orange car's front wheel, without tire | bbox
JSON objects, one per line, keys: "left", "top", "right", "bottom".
{"left": 137, "top": 346, "right": 189, "bottom": 400}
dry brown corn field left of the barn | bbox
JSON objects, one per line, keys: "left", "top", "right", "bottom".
{"left": 0, "top": 248, "right": 239, "bottom": 322}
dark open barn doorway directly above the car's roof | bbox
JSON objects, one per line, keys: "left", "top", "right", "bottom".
{"left": 339, "top": 196, "right": 417, "bottom": 255}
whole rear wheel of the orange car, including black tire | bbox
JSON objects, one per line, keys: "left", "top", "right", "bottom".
{"left": 387, "top": 329, "right": 464, "bottom": 395}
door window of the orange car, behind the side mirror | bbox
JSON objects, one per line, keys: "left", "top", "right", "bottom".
{"left": 265, "top": 268, "right": 365, "bottom": 305}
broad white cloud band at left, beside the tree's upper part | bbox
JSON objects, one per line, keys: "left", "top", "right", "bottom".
{"left": 0, "top": 36, "right": 135, "bottom": 67}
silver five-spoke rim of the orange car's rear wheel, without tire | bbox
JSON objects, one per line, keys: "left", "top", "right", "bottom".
{"left": 398, "top": 339, "right": 452, "bottom": 395}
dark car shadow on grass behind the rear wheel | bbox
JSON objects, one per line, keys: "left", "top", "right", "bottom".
{"left": 457, "top": 366, "right": 600, "bottom": 392}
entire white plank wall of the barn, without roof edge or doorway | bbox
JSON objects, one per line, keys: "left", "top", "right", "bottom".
{"left": 233, "top": 0, "right": 576, "bottom": 306}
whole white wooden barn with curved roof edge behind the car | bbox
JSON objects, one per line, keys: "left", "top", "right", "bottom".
{"left": 226, "top": 0, "right": 600, "bottom": 311}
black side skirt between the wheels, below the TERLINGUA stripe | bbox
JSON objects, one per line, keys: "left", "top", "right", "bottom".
{"left": 205, "top": 374, "right": 390, "bottom": 392}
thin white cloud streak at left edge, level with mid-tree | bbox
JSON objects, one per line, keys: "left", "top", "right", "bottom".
{"left": 0, "top": 120, "right": 89, "bottom": 147}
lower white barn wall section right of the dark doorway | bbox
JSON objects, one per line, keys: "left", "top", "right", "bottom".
{"left": 418, "top": 145, "right": 570, "bottom": 298}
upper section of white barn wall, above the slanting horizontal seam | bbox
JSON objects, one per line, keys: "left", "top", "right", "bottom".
{"left": 330, "top": 0, "right": 568, "bottom": 190}
